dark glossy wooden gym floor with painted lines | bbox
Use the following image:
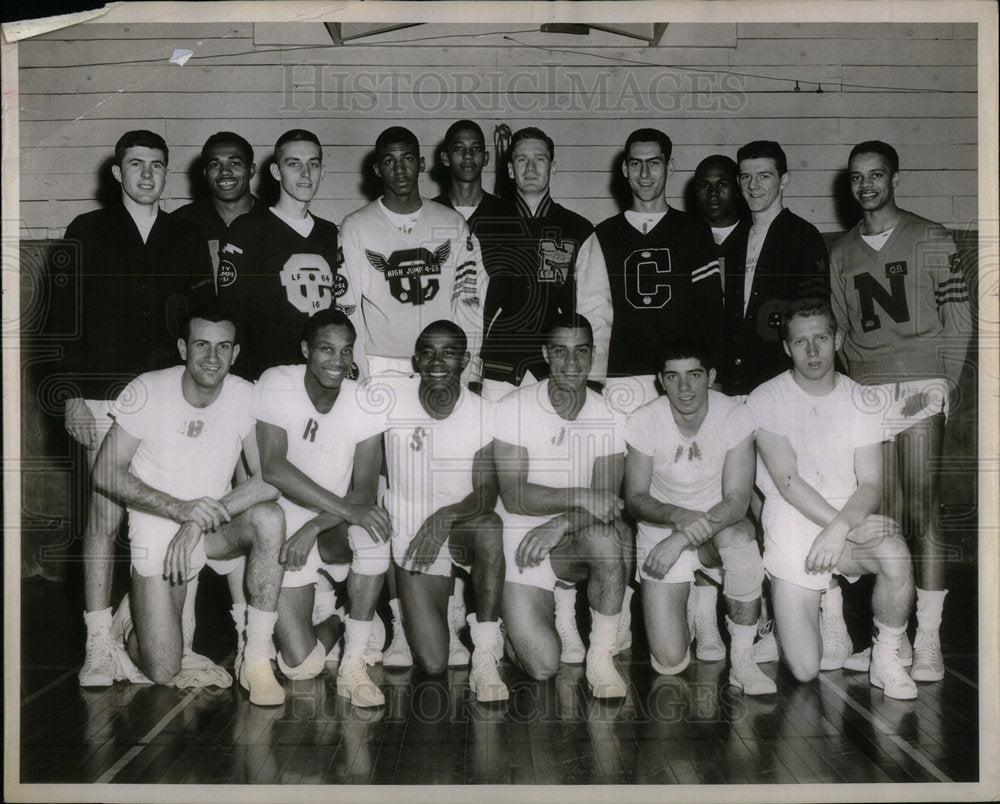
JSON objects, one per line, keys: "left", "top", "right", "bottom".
{"left": 11, "top": 536, "right": 980, "bottom": 794}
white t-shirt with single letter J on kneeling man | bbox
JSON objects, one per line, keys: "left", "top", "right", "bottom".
{"left": 490, "top": 380, "right": 625, "bottom": 489}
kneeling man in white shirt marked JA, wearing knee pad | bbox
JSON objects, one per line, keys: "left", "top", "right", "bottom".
{"left": 625, "top": 340, "right": 777, "bottom": 695}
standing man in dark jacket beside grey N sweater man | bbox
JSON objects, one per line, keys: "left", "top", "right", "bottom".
{"left": 719, "top": 140, "right": 830, "bottom": 394}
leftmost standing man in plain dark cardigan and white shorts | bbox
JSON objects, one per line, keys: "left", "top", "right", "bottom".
{"left": 63, "top": 130, "right": 212, "bottom": 686}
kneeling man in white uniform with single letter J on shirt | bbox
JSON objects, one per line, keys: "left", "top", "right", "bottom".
{"left": 492, "top": 314, "right": 628, "bottom": 698}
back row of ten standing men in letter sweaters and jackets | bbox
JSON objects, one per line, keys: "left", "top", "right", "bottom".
{"left": 60, "top": 121, "right": 971, "bottom": 708}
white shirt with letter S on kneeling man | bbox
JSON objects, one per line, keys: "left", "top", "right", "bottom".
{"left": 385, "top": 378, "right": 492, "bottom": 535}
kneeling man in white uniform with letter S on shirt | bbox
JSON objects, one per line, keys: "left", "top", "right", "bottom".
{"left": 382, "top": 320, "right": 508, "bottom": 702}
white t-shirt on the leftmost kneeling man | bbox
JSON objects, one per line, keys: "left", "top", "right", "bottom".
{"left": 110, "top": 366, "right": 254, "bottom": 521}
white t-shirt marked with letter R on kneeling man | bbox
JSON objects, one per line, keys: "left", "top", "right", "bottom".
{"left": 252, "top": 365, "right": 387, "bottom": 510}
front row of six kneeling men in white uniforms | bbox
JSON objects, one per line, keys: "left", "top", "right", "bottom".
{"left": 95, "top": 299, "right": 916, "bottom": 706}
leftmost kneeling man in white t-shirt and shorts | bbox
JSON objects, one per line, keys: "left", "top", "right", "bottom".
{"left": 94, "top": 310, "right": 285, "bottom": 705}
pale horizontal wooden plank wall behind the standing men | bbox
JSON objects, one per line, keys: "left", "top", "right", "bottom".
{"left": 19, "top": 22, "right": 977, "bottom": 238}
